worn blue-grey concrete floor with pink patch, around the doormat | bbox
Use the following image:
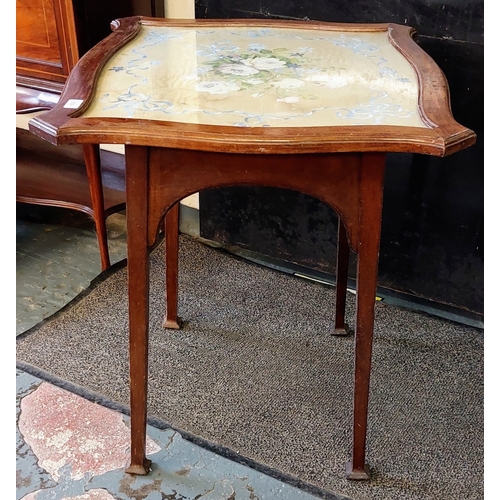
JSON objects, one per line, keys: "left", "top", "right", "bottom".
{"left": 16, "top": 205, "right": 324, "bottom": 500}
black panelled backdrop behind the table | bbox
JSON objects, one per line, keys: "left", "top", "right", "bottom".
{"left": 196, "top": 0, "right": 484, "bottom": 318}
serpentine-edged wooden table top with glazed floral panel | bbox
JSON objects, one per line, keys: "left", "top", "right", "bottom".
{"left": 30, "top": 17, "right": 475, "bottom": 155}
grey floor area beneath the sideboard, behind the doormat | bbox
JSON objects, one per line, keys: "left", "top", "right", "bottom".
{"left": 16, "top": 204, "right": 127, "bottom": 334}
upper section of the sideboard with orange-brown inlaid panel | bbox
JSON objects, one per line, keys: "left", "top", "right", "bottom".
{"left": 16, "top": 0, "right": 164, "bottom": 112}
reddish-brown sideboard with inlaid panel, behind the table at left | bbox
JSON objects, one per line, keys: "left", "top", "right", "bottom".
{"left": 16, "top": 0, "right": 164, "bottom": 269}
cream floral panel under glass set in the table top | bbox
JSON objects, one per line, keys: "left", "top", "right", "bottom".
{"left": 83, "top": 26, "right": 425, "bottom": 127}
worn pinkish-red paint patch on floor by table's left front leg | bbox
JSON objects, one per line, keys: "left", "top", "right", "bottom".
{"left": 19, "top": 382, "right": 160, "bottom": 480}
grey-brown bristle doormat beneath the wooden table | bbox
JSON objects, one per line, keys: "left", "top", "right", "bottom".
{"left": 17, "top": 236, "right": 484, "bottom": 500}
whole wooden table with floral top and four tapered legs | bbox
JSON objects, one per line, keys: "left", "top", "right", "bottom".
{"left": 29, "top": 17, "right": 475, "bottom": 479}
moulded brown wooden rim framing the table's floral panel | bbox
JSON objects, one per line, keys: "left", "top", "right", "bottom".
{"left": 33, "top": 16, "right": 476, "bottom": 156}
